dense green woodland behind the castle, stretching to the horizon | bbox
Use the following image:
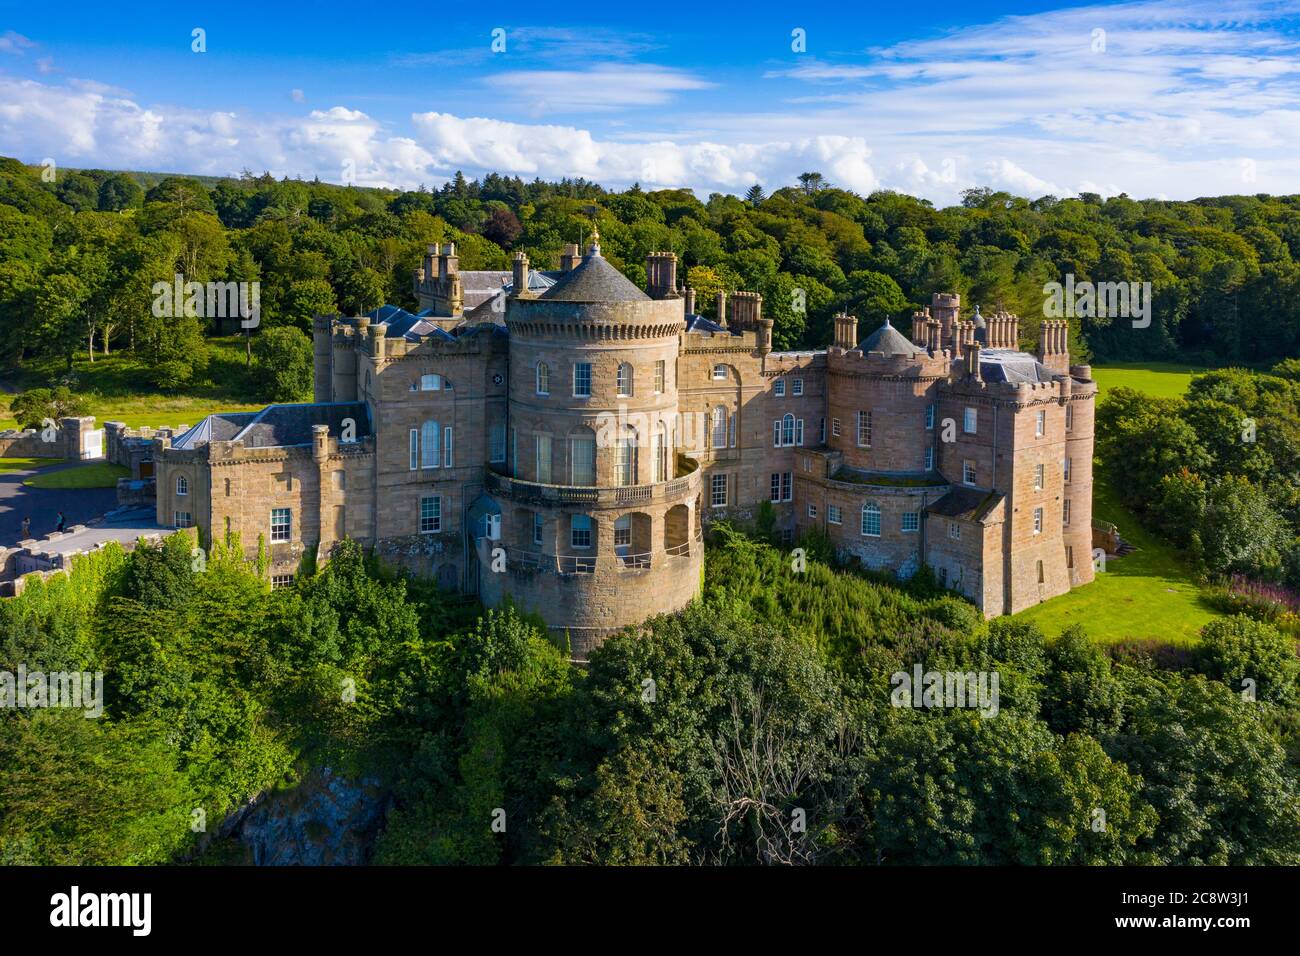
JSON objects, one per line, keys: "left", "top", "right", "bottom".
{"left": 0, "top": 159, "right": 1300, "bottom": 386}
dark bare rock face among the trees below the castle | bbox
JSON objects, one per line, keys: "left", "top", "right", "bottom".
{"left": 221, "top": 767, "right": 390, "bottom": 866}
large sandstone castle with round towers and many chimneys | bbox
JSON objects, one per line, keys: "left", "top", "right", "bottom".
{"left": 155, "top": 237, "right": 1096, "bottom": 658}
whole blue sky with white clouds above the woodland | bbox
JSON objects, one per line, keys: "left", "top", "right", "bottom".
{"left": 0, "top": 0, "right": 1300, "bottom": 203}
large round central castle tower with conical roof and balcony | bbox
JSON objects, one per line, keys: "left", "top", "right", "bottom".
{"left": 476, "top": 237, "right": 703, "bottom": 659}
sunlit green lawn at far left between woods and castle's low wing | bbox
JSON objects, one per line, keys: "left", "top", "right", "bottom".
{"left": 0, "top": 336, "right": 274, "bottom": 429}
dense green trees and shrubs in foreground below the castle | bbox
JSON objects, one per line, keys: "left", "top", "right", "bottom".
{"left": 0, "top": 527, "right": 1300, "bottom": 865}
